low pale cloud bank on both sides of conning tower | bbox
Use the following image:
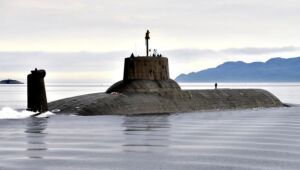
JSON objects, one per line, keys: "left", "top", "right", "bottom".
{"left": 0, "top": 47, "right": 300, "bottom": 82}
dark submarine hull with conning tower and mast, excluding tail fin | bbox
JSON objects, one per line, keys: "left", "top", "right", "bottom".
{"left": 31, "top": 31, "right": 284, "bottom": 115}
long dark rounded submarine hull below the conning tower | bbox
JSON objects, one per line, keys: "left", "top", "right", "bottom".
{"left": 49, "top": 89, "right": 283, "bottom": 115}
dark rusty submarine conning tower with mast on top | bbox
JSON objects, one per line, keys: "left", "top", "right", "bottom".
{"left": 106, "top": 30, "right": 181, "bottom": 93}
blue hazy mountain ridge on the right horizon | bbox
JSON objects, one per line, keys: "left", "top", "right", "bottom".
{"left": 176, "top": 57, "right": 300, "bottom": 82}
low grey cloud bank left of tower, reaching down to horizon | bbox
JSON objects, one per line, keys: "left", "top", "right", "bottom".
{"left": 0, "top": 51, "right": 130, "bottom": 82}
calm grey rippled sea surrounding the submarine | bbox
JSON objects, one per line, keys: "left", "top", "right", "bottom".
{"left": 0, "top": 83, "right": 300, "bottom": 170}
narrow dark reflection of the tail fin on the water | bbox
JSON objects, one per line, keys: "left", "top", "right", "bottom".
{"left": 25, "top": 117, "right": 47, "bottom": 159}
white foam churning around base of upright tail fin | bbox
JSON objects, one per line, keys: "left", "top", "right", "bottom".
{"left": 0, "top": 107, "right": 53, "bottom": 119}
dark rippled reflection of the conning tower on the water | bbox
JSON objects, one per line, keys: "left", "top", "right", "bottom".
{"left": 122, "top": 114, "right": 170, "bottom": 152}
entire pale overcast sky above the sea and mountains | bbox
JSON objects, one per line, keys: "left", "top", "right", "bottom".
{"left": 0, "top": 0, "right": 300, "bottom": 82}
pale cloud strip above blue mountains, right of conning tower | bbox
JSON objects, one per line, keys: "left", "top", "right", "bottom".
{"left": 163, "top": 46, "right": 300, "bottom": 77}
